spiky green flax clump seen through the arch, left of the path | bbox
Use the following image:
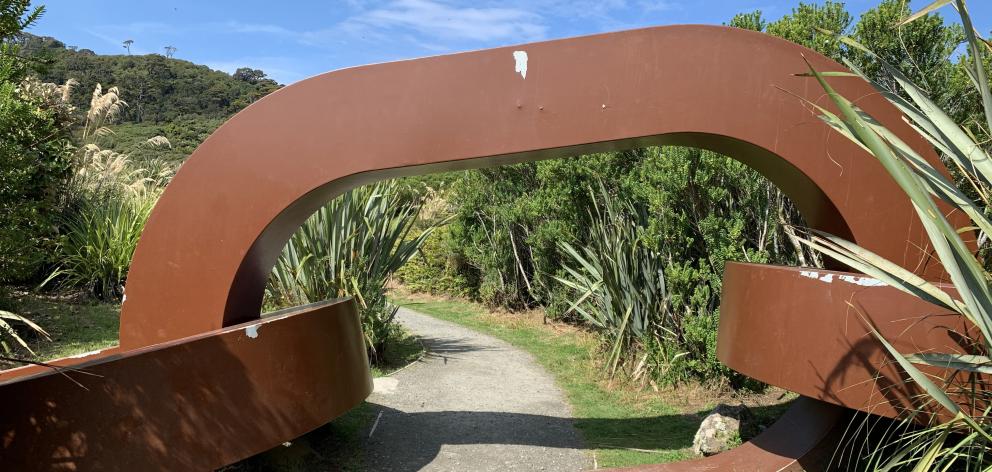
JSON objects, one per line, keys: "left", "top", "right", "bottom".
{"left": 266, "top": 181, "right": 443, "bottom": 362}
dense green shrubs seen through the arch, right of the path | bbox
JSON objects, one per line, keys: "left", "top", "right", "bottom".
{"left": 424, "top": 148, "right": 817, "bottom": 384}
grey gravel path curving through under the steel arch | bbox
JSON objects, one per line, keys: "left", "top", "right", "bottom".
{"left": 366, "top": 308, "right": 592, "bottom": 472}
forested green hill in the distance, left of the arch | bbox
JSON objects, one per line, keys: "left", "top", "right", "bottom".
{"left": 18, "top": 33, "right": 281, "bottom": 159}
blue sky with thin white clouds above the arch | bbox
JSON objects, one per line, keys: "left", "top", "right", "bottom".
{"left": 30, "top": 0, "right": 992, "bottom": 83}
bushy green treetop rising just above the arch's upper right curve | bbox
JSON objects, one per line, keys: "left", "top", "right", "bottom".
{"left": 768, "top": 0, "right": 852, "bottom": 61}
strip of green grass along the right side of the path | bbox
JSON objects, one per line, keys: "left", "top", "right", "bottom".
{"left": 393, "top": 298, "right": 708, "bottom": 467}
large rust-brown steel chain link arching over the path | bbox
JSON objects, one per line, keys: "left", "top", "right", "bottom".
{"left": 121, "top": 26, "right": 939, "bottom": 349}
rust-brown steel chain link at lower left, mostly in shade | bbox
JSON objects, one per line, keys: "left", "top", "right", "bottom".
{"left": 0, "top": 299, "right": 372, "bottom": 472}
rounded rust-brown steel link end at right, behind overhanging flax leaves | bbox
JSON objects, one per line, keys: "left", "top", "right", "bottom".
{"left": 717, "top": 263, "right": 988, "bottom": 417}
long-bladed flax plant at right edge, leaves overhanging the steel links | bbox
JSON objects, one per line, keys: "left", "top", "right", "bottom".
{"left": 805, "top": 0, "right": 992, "bottom": 464}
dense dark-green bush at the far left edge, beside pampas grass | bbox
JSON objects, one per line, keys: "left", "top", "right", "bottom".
{"left": 0, "top": 1, "right": 72, "bottom": 283}
